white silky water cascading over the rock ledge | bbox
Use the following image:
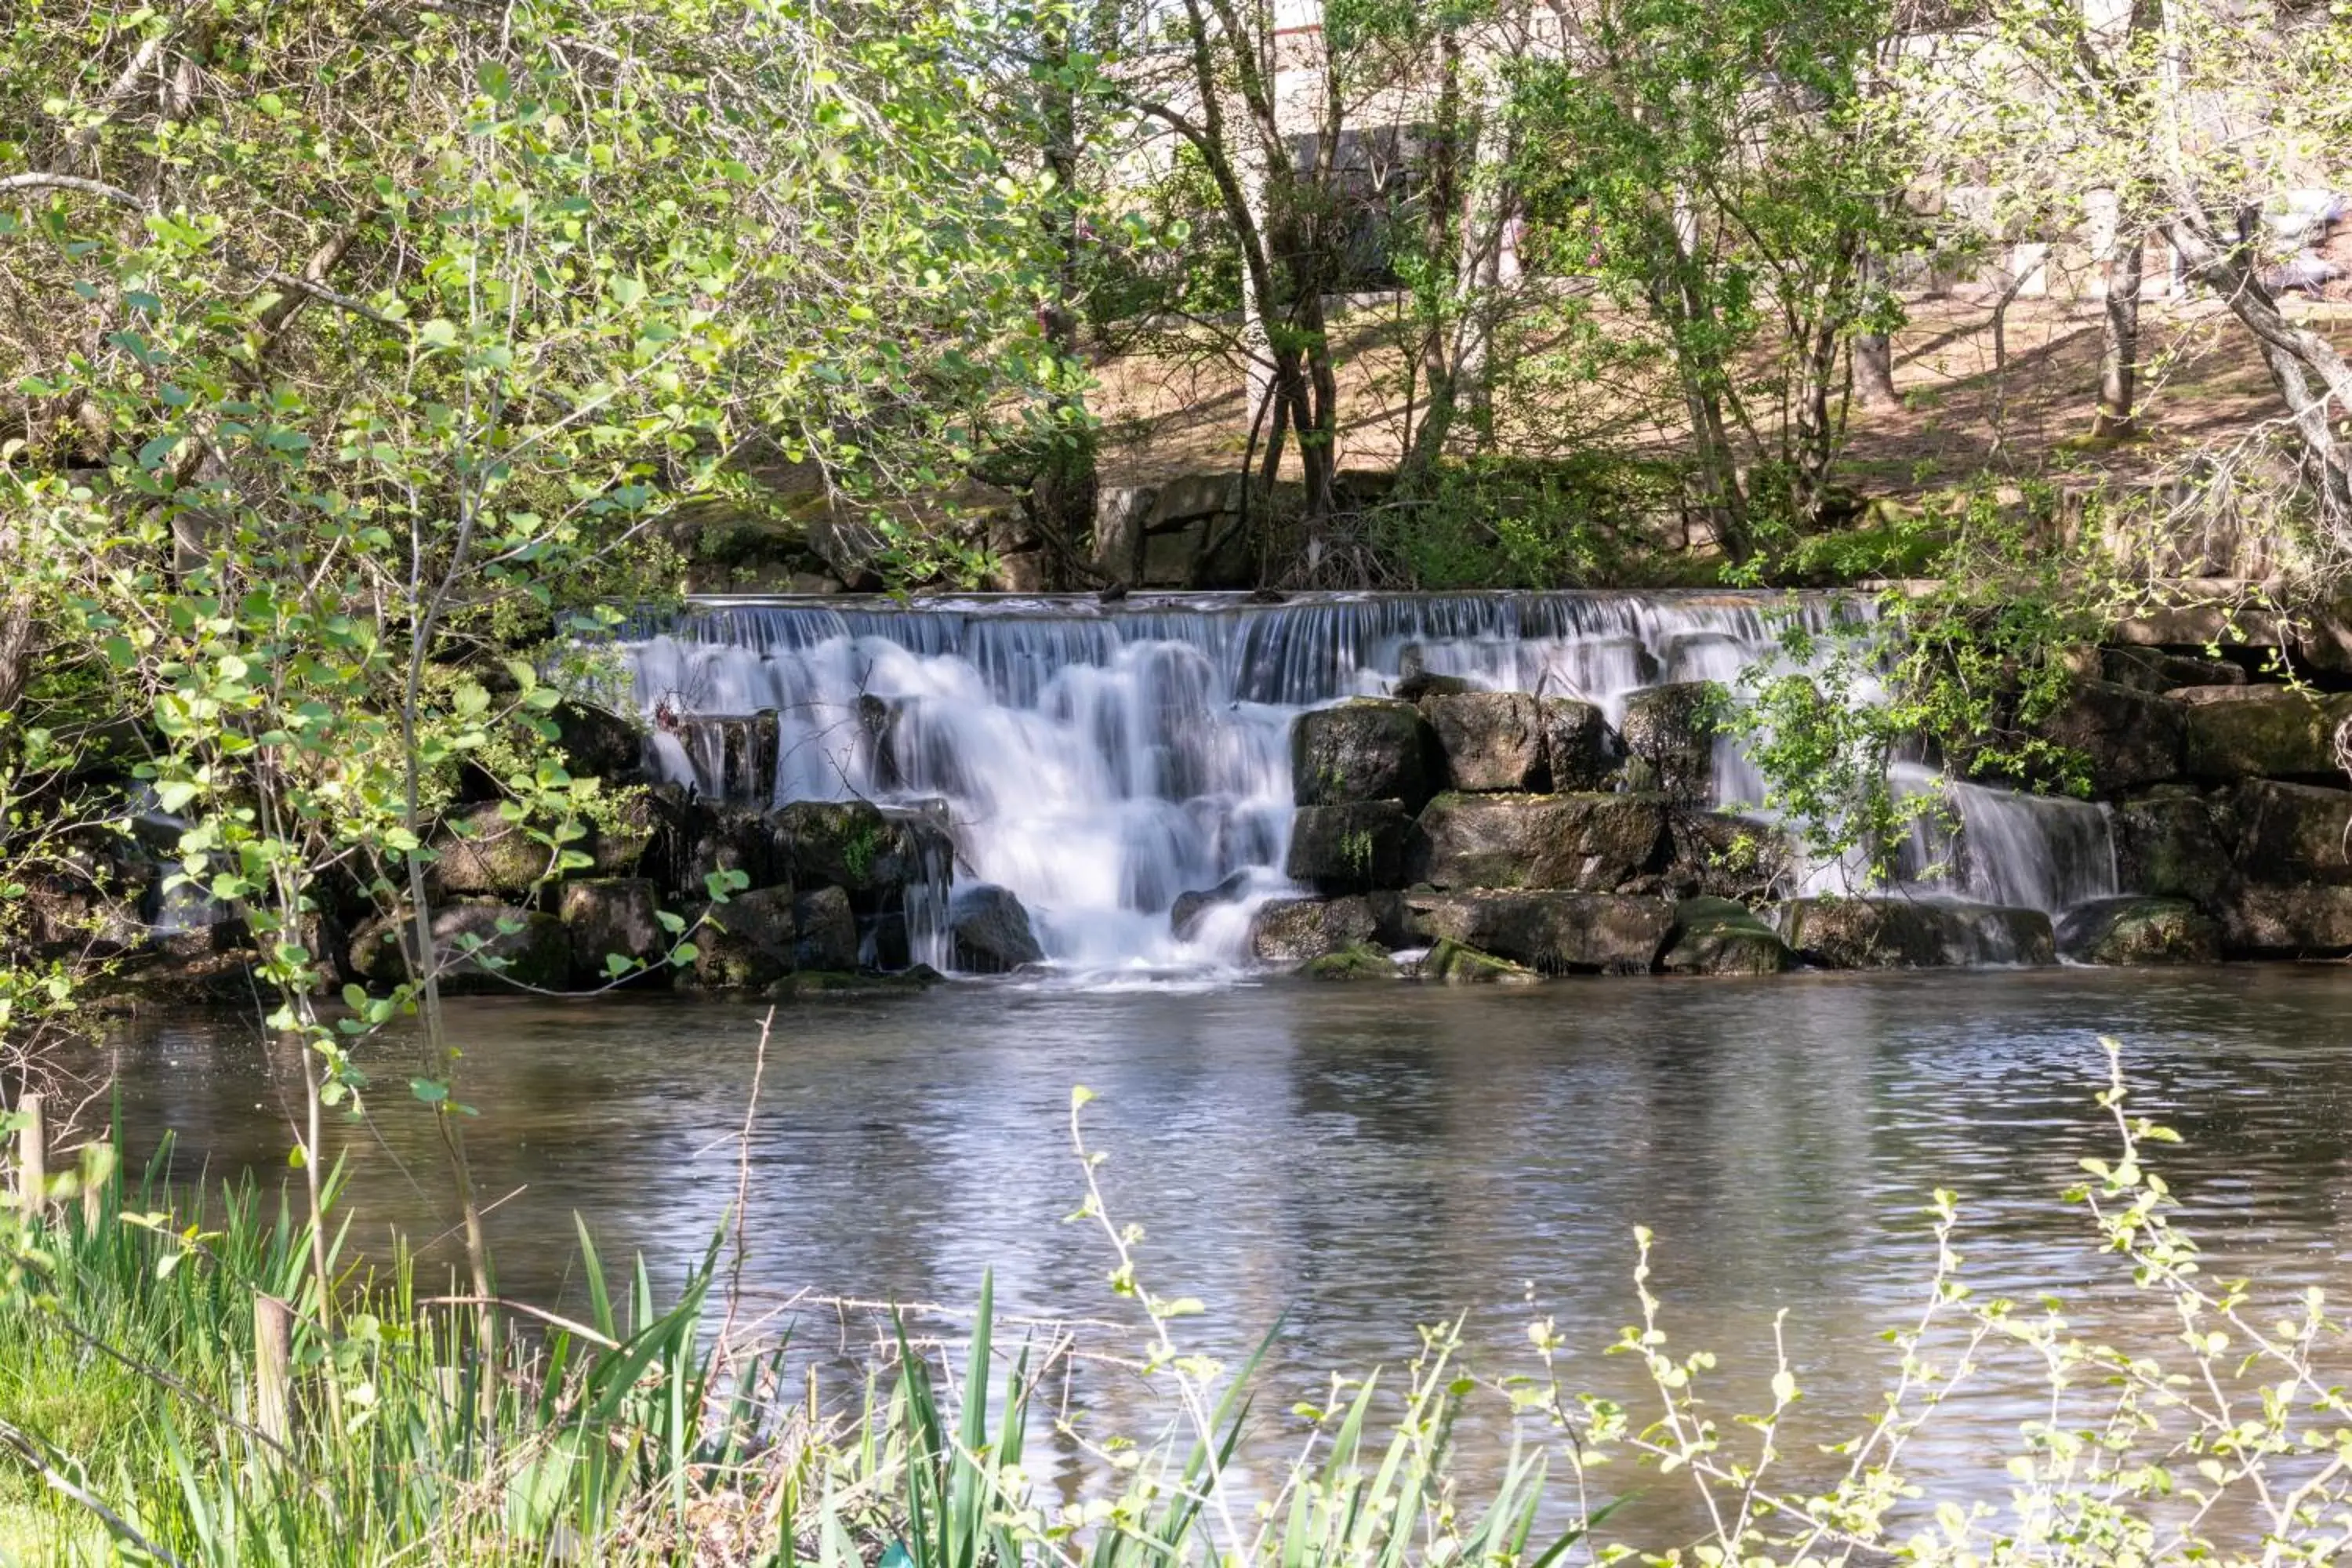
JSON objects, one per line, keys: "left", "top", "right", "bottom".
{"left": 623, "top": 593, "right": 2114, "bottom": 980}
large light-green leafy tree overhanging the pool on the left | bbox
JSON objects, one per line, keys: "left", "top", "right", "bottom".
{"left": 0, "top": 0, "right": 1063, "bottom": 1335}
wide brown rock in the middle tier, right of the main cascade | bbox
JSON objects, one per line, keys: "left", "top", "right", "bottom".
{"left": 1406, "top": 794, "right": 1665, "bottom": 891}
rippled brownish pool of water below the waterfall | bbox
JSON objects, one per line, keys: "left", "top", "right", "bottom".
{"left": 101, "top": 966, "right": 2352, "bottom": 1542}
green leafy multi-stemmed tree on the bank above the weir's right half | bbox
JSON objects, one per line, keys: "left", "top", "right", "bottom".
{"left": 1512, "top": 0, "right": 1917, "bottom": 560}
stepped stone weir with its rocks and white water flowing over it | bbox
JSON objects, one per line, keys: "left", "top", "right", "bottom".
{"left": 597, "top": 593, "right": 2305, "bottom": 980}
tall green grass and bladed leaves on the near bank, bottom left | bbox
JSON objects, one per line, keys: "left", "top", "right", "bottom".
{"left": 0, "top": 1147, "right": 1564, "bottom": 1568}
